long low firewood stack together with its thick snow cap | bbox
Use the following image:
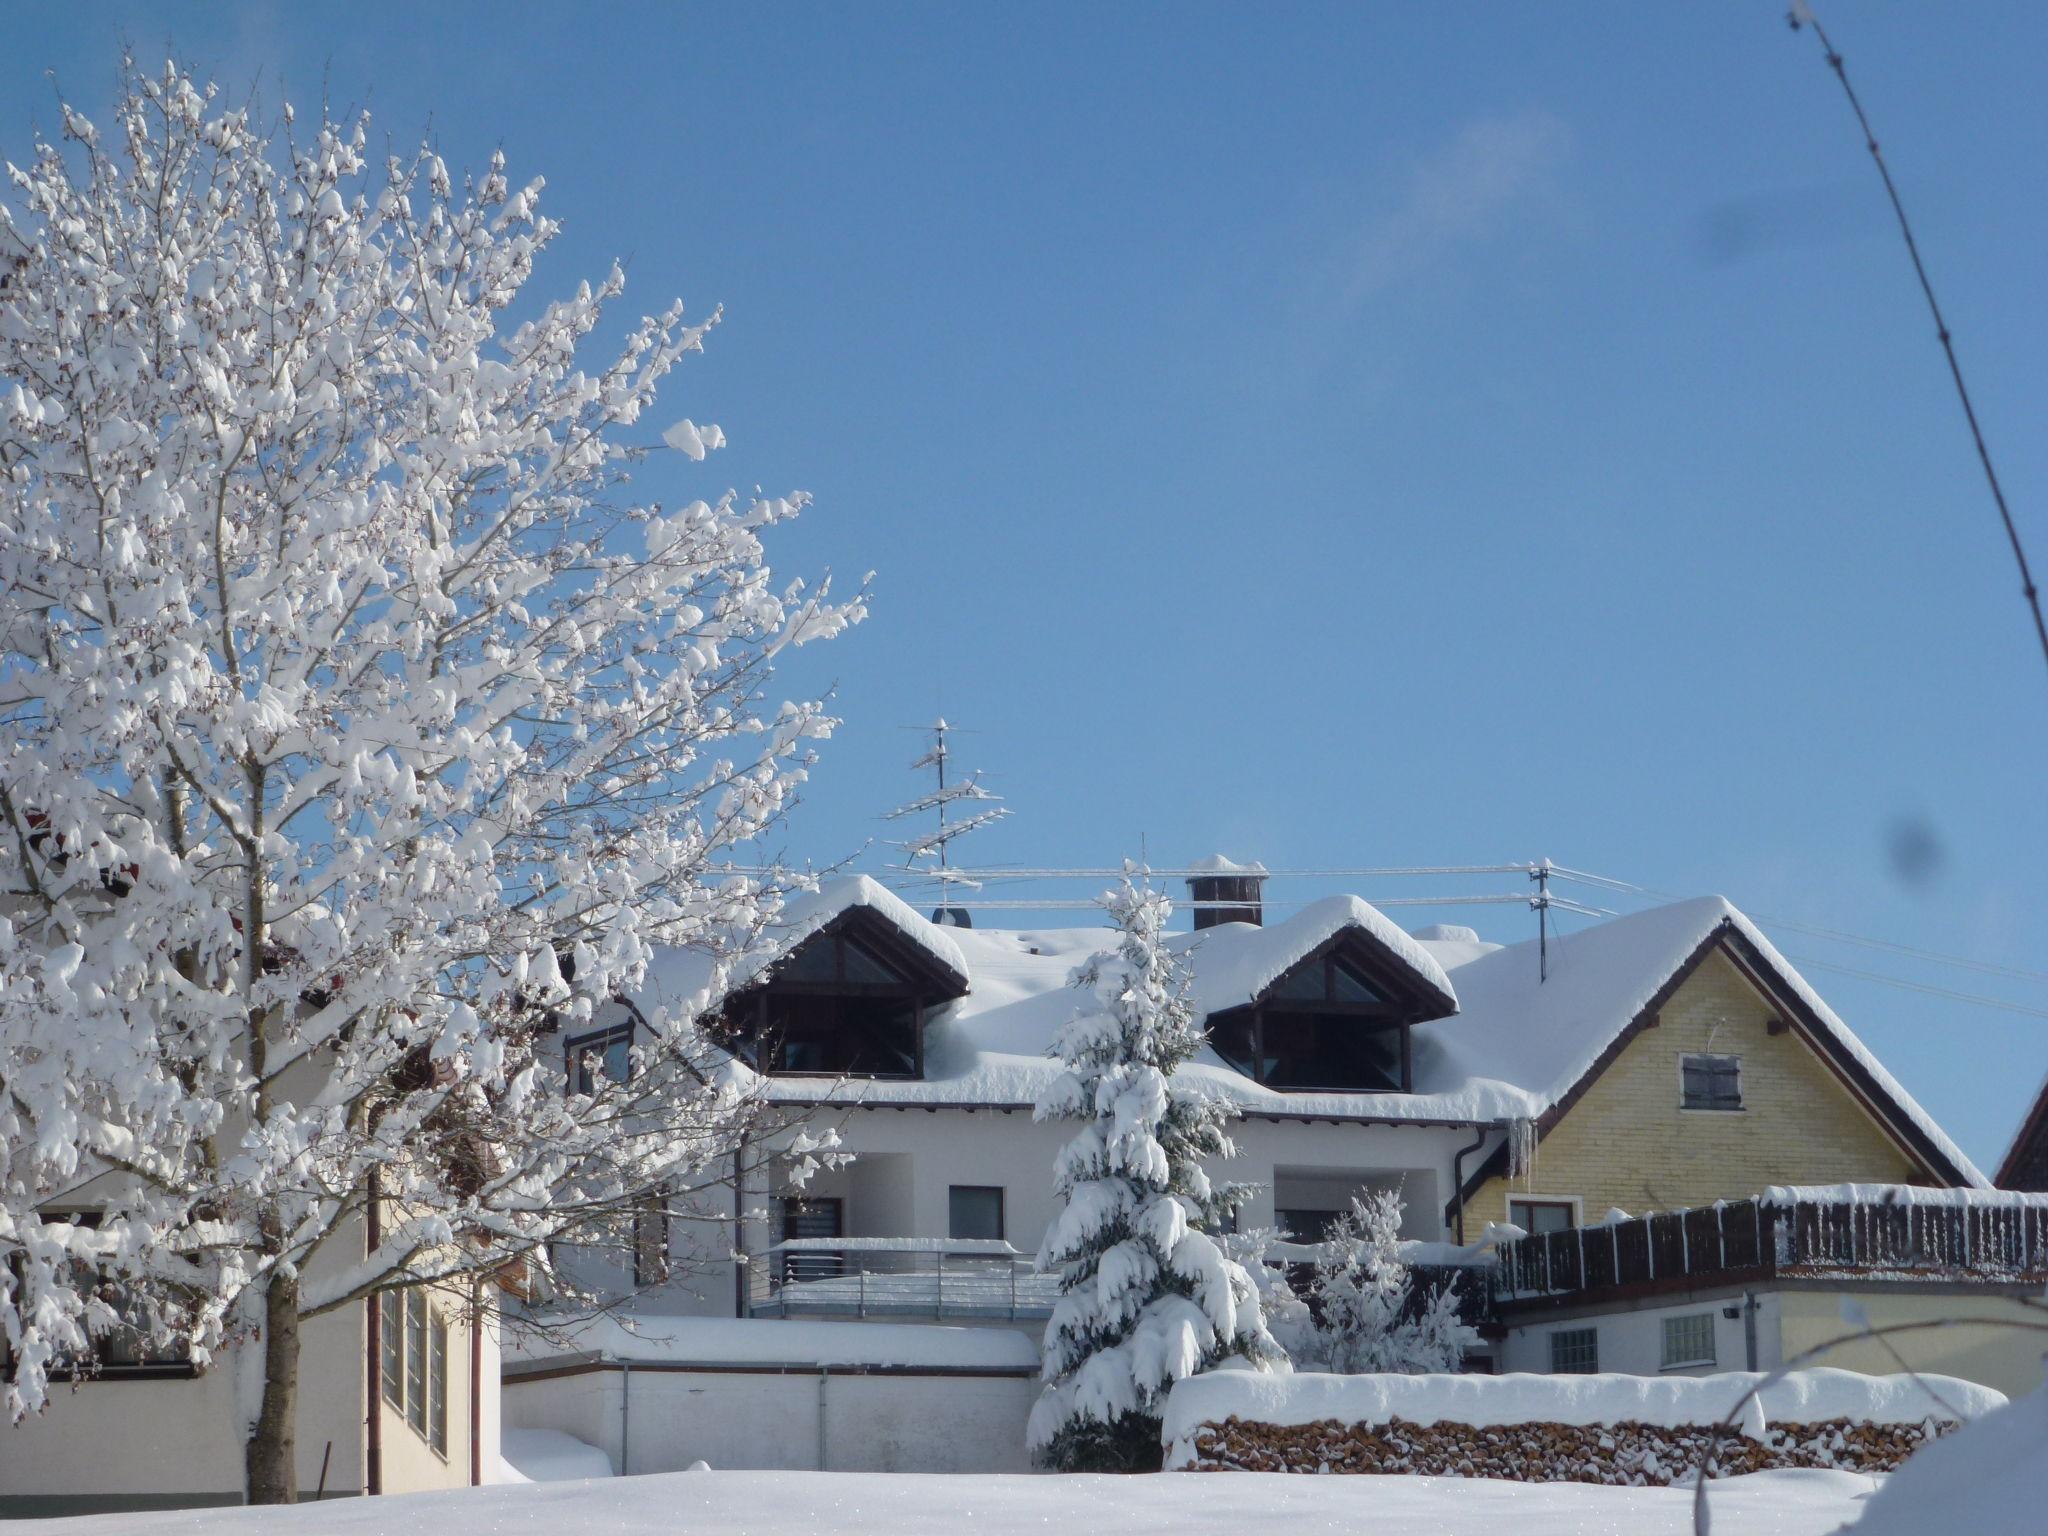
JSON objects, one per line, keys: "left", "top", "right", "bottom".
{"left": 1163, "top": 1370, "right": 2005, "bottom": 1483}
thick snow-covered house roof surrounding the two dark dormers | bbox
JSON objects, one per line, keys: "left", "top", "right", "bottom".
{"left": 649, "top": 877, "right": 1987, "bottom": 1186}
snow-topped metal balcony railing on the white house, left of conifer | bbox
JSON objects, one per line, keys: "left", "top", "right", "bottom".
{"left": 748, "top": 1237, "right": 1059, "bottom": 1323}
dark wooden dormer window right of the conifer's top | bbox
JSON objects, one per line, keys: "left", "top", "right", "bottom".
{"left": 1208, "top": 934, "right": 1444, "bottom": 1094}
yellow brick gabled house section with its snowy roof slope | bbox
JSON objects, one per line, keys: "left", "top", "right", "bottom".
{"left": 1448, "top": 897, "right": 1987, "bottom": 1233}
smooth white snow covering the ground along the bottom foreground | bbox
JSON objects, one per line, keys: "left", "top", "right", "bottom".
{"left": 10, "top": 1473, "right": 1875, "bottom": 1536}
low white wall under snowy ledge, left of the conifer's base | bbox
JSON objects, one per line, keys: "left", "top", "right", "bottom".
{"left": 504, "top": 1366, "right": 1038, "bottom": 1473}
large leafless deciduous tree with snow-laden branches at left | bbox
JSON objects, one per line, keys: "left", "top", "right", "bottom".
{"left": 0, "top": 66, "right": 860, "bottom": 1501}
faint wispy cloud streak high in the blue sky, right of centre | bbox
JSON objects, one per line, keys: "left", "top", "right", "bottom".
{"left": 1346, "top": 111, "right": 1571, "bottom": 305}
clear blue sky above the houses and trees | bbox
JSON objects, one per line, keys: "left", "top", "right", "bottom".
{"left": 0, "top": 4, "right": 2048, "bottom": 1161}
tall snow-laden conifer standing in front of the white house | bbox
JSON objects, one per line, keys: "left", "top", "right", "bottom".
{"left": 1028, "top": 879, "right": 1280, "bottom": 1470}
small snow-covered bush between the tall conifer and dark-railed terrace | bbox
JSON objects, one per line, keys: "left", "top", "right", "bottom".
{"left": 1292, "top": 1190, "right": 1466, "bottom": 1376}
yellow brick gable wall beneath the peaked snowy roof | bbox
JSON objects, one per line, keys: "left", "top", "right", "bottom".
{"left": 1466, "top": 950, "right": 1925, "bottom": 1233}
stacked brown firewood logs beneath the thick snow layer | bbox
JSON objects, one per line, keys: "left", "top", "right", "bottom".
{"left": 1192, "top": 1415, "right": 1956, "bottom": 1487}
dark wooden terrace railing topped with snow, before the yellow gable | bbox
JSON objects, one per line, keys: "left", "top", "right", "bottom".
{"left": 1493, "top": 1184, "right": 2048, "bottom": 1300}
